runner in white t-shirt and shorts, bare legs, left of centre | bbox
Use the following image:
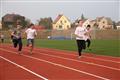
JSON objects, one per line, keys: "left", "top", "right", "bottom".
{"left": 25, "top": 24, "right": 37, "bottom": 54}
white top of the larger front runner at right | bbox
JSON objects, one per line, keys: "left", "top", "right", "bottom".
{"left": 75, "top": 26, "right": 86, "bottom": 40}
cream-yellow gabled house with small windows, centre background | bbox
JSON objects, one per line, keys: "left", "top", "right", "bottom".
{"left": 53, "top": 14, "right": 71, "bottom": 30}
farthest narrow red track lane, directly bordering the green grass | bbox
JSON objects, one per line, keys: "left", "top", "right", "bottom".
{"left": 38, "top": 47, "right": 120, "bottom": 62}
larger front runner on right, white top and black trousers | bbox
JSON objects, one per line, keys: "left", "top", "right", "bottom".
{"left": 75, "top": 20, "right": 86, "bottom": 58}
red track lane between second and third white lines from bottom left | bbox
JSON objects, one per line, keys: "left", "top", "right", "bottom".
{"left": 22, "top": 51, "right": 120, "bottom": 80}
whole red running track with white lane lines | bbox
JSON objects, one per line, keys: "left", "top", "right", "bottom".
{"left": 0, "top": 44, "right": 120, "bottom": 80}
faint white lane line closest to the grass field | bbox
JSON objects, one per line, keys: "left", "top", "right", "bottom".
{"left": 36, "top": 49, "right": 120, "bottom": 63}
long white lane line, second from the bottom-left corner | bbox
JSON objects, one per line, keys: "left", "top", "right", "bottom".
{"left": 0, "top": 48, "right": 110, "bottom": 80}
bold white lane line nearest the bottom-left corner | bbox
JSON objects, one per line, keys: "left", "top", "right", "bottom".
{"left": 0, "top": 56, "right": 48, "bottom": 80}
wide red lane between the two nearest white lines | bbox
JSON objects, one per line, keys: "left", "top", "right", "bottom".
{"left": 0, "top": 50, "right": 99, "bottom": 80}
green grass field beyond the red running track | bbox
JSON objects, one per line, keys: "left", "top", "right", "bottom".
{"left": 1, "top": 39, "right": 120, "bottom": 57}
